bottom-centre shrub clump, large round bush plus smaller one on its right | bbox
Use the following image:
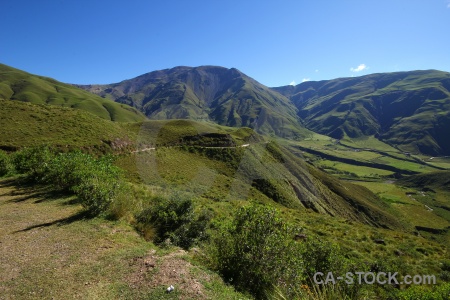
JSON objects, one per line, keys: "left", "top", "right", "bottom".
{"left": 207, "top": 204, "right": 360, "bottom": 299}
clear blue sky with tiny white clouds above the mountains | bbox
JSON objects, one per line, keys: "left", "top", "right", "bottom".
{"left": 0, "top": 0, "right": 450, "bottom": 87}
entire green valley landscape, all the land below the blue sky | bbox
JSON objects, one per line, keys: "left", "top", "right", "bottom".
{"left": 0, "top": 65, "right": 450, "bottom": 299}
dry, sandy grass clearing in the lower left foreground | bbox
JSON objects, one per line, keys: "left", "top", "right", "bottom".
{"left": 0, "top": 180, "right": 239, "bottom": 300}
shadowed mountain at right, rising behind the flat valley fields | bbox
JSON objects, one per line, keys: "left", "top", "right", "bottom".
{"left": 273, "top": 70, "right": 450, "bottom": 155}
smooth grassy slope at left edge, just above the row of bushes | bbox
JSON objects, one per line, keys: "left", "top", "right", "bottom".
{"left": 0, "top": 100, "right": 136, "bottom": 151}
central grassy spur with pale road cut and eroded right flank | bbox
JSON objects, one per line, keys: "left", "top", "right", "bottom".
{"left": 112, "top": 120, "right": 401, "bottom": 228}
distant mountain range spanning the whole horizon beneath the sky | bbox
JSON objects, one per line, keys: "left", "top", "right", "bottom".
{"left": 0, "top": 65, "right": 450, "bottom": 156}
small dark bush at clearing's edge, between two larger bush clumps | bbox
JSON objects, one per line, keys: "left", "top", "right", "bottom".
{"left": 136, "top": 195, "right": 211, "bottom": 249}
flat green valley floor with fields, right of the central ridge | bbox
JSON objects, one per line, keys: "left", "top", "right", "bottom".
{"left": 280, "top": 135, "right": 450, "bottom": 245}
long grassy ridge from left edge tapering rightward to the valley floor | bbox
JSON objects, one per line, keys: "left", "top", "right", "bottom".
{"left": 0, "top": 100, "right": 398, "bottom": 227}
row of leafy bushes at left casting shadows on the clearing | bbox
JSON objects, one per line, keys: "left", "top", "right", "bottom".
{"left": 13, "top": 147, "right": 123, "bottom": 215}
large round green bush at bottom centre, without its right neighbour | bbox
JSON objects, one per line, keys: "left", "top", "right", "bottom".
{"left": 209, "top": 205, "right": 304, "bottom": 299}
